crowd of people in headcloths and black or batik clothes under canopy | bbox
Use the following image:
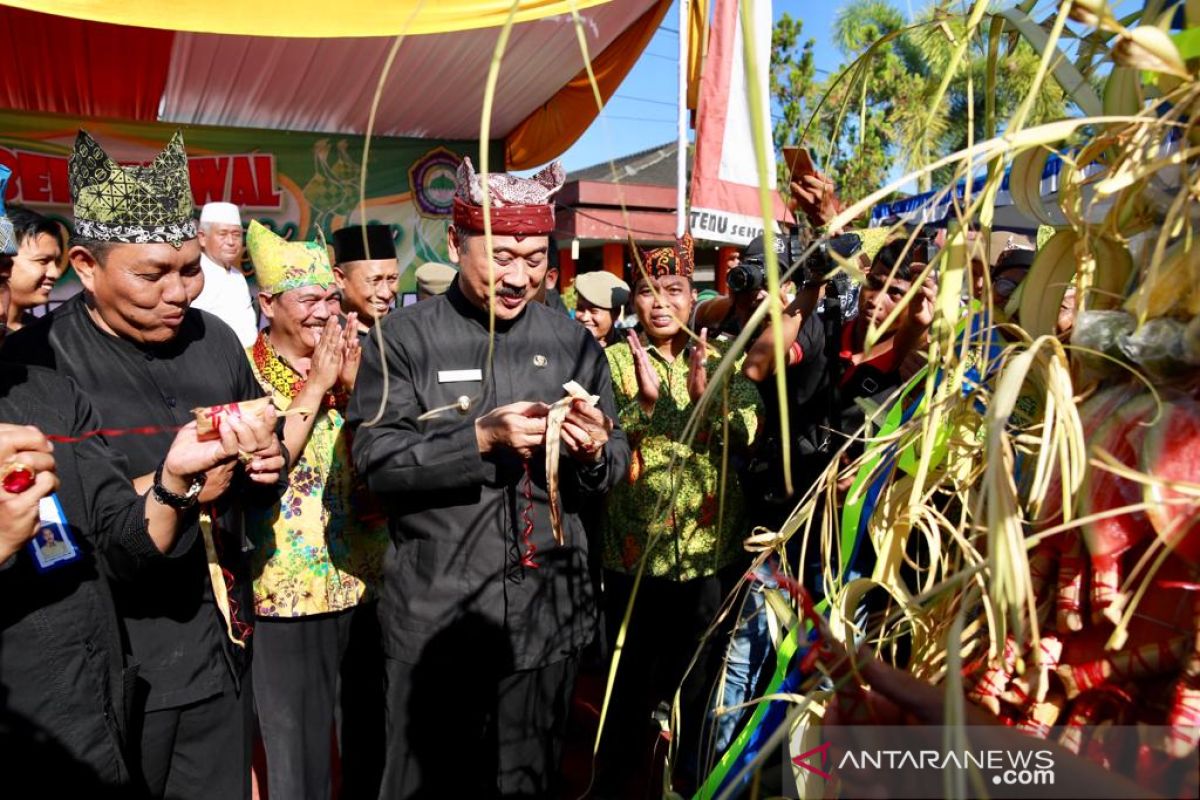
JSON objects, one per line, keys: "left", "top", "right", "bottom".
{"left": 0, "top": 132, "right": 1056, "bottom": 799}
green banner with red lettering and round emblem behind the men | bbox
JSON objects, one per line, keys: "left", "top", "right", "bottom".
{"left": 0, "top": 110, "right": 503, "bottom": 293}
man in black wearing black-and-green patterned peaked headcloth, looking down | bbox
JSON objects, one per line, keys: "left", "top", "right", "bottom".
{"left": 4, "top": 131, "right": 285, "bottom": 798}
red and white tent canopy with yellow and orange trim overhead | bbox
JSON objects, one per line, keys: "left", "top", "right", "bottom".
{"left": 0, "top": 0, "right": 670, "bottom": 168}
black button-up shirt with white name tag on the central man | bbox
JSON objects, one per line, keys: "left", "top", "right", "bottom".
{"left": 347, "top": 282, "right": 629, "bottom": 669}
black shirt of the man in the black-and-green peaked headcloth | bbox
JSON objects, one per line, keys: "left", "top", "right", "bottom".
{"left": 4, "top": 294, "right": 263, "bottom": 711}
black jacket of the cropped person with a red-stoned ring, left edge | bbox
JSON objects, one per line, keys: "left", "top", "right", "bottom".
{"left": 0, "top": 363, "right": 197, "bottom": 796}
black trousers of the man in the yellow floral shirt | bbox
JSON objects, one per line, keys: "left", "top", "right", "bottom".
{"left": 254, "top": 603, "right": 384, "bottom": 800}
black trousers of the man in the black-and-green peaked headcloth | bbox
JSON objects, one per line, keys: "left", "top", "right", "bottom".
{"left": 131, "top": 673, "right": 254, "bottom": 800}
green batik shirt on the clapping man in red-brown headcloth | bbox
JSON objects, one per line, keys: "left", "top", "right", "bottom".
{"left": 604, "top": 339, "right": 762, "bottom": 581}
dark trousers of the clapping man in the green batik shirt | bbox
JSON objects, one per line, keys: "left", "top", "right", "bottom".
{"left": 599, "top": 563, "right": 745, "bottom": 796}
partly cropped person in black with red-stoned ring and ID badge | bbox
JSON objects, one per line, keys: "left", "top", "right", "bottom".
{"left": 0, "top": 178, "right": 283, "bottom": 798}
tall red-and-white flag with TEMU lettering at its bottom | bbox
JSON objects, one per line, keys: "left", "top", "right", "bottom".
{"left": 690, "top": 0, "right": 787, "bottom": 246}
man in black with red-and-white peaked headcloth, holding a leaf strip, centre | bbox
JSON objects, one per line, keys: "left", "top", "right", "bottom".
{"left": 347, "top": 161, "right": 629, "bottom": 798}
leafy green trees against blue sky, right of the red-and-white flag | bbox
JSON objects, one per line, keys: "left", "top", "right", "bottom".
{"left": 772, "top": 0, "right": 1067, "bottom": 201}
